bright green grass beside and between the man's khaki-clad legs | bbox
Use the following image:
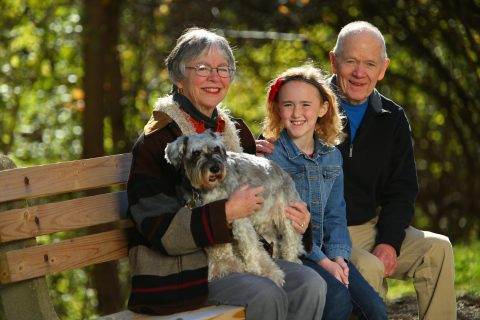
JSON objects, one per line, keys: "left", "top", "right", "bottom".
{"left": 387, "top": 240, "right": 480, "bottom": 300}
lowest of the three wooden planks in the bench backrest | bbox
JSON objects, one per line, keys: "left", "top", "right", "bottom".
{"left": 0, "top": 229, "right": 128, "bottom": 283}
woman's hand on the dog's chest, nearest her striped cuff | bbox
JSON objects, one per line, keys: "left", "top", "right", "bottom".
{"left": 225, "top": 185, "right": 265, "bottom": 223}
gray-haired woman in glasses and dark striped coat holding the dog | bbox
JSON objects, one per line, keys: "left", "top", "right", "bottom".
{"left": 128, "top": 28, "right": 326, "bottom": 319}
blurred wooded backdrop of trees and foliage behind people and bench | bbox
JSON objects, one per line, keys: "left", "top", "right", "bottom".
{"left": 0, "top": 0, "right": 480, "bottom": 319}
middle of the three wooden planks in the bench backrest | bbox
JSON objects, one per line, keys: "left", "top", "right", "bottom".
{"left": 0, "top": 191, "right": 128, "bottom": 243}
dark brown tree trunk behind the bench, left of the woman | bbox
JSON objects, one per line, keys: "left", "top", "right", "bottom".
{"left": 83, "top": 0, "right": 123, "bottom": 315}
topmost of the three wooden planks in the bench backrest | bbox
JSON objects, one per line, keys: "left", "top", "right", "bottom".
{"left": 0, "top": 153, "right": 132, "bottom": 202}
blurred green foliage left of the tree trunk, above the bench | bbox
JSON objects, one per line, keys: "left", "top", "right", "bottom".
{"left": 0, "top": 0, "right": 82, "bottom": 165}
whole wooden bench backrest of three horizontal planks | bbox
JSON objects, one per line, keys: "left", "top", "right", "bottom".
{"left": 0, "top": 154, "right": 132, "bottom": 284}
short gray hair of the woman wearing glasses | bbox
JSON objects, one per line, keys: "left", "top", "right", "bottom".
{"left": 165, "top": 27, "right": 235, "bottom": 84}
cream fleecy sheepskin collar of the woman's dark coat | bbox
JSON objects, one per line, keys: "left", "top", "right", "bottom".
{"left": 144, "top": 96, "right": 243, "bottom": 152}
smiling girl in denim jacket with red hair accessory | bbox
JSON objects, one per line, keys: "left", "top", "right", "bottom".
{"left": 263, "top": 65, "right": 387, "bottom": 320}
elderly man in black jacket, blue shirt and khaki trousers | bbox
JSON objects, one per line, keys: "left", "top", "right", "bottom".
{"left": 330, "top": 21, "right": 456, "bottom": 319}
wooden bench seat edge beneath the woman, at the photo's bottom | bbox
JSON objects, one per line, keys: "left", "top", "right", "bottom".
{"left": 100, "top": 305, "right": 245, "bottom": 320}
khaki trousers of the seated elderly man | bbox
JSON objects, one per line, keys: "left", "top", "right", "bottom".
{"left": 348, "top": 219, "right": 457, "bottom": 320}
